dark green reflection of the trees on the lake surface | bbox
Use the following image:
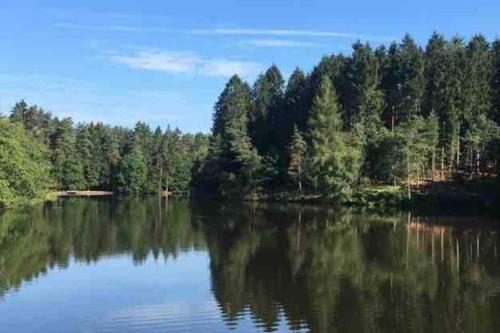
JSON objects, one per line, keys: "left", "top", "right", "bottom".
{"left": 0, "top": 198, "right": 500, "bottom": 332}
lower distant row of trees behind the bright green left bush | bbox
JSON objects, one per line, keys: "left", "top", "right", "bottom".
{"left": 0, "top": 101, "right": 208, "bottom": 201}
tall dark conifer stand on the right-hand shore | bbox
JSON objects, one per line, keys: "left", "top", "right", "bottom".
{"left": 195, "top": 33, "right": 500, "bottom": 197}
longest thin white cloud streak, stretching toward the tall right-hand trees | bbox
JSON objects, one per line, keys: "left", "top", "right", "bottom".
{"left": 190, "top": 29, "right": 396, "bottom": 41}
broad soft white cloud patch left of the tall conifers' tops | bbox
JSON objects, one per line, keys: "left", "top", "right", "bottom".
{"left": 108, "top": 50, "right": 263, "bottom": 77}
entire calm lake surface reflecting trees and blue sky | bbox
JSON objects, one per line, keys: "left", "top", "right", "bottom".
{"left": 0, "top": 198, "right": 500, "bottom": 333}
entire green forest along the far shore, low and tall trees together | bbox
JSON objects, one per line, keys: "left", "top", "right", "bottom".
{"left": 0, "top": 33, "right": 500, "bottom": 207}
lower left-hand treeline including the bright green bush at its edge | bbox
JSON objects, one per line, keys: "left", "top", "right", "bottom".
{"left": 0, "top": 101, "right": 208, "bottom": 206}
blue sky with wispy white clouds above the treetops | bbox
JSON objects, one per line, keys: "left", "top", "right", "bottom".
{"left": 0, "top": 0, "right": 500, "bottom": 131}
